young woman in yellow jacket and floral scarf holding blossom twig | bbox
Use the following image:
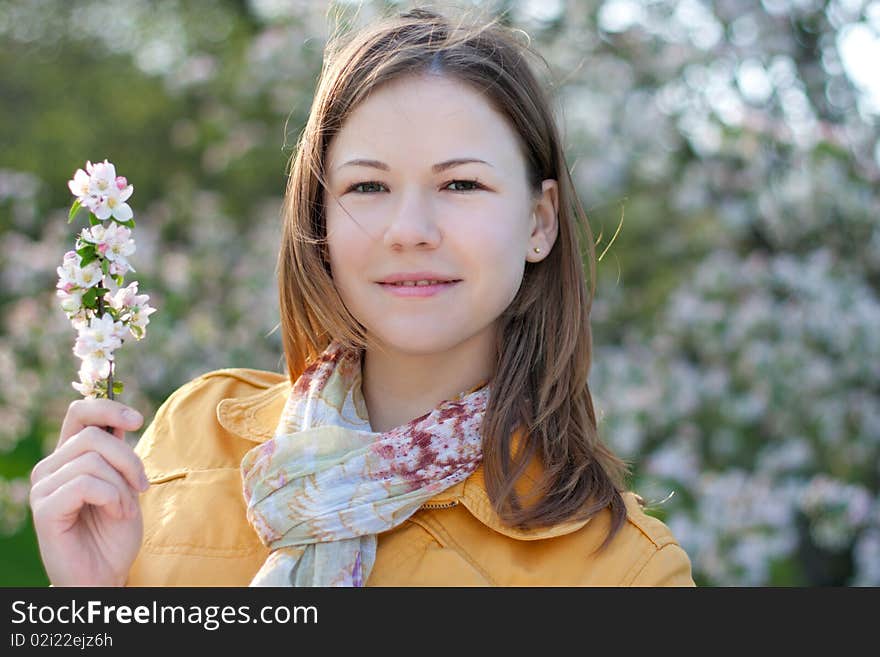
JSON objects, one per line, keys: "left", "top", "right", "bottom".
{"left": 31, "top": 10, "right": 693, "bottom": 586}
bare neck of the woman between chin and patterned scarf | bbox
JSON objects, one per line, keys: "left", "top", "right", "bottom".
{"left": 361, "top": 335, "right": 494, "bottom": 433}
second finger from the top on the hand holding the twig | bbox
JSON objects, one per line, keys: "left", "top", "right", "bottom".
{"left": 31, "top": 426, "right": 149, "bottom": 491}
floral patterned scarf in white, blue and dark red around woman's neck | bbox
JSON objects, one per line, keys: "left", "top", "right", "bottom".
{"left": 241, "top": 341, "right": 489, "bottom": 586}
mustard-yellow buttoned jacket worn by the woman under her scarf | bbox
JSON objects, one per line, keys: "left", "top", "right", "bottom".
{"left": 127, "top": 369, "right": 694, "bottom": 586}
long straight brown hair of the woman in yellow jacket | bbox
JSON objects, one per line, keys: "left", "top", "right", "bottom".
{"left": 278, "top": 3, "right": 629, "bottom": 548}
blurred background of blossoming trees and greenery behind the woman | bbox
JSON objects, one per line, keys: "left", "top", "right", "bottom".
{"left": 0, "top": 0, "right": 880, "bottom": 586}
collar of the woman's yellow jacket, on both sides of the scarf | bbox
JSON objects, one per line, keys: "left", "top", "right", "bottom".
{"left": 217, "top": 380, "right": 589, "bottom": 541}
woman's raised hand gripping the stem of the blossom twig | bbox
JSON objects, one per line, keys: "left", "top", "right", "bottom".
{"left": 30, "top": 399, "right": 149, "bottom": 586}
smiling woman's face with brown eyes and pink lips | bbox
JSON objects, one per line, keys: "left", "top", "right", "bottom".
{"left": 324, "top": 76, "right": 555, "bottom": 354}
